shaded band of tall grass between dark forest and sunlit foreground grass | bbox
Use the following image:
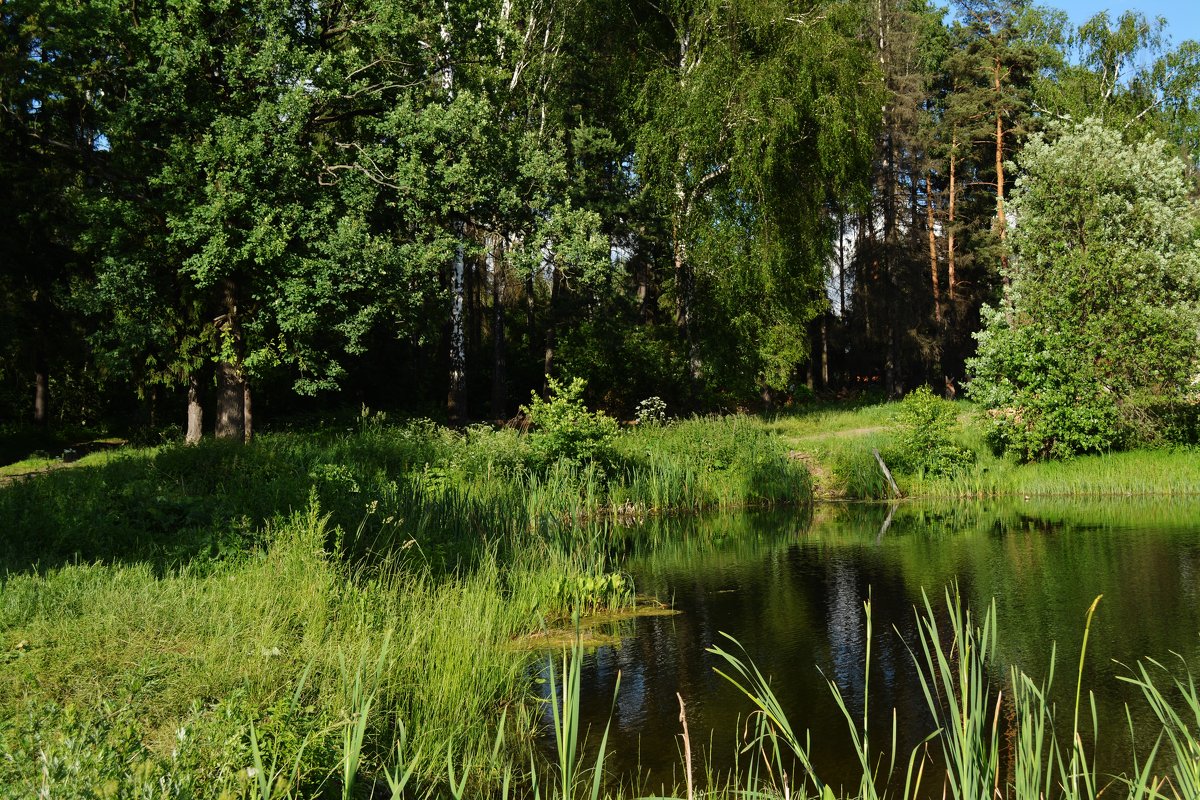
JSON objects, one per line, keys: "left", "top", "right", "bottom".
{"left": 0, "top": 419, "right": 810, "bottom": 572}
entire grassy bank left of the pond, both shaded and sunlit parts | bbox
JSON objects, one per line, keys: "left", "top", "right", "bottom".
{"left": 0, "top": 417, "right": 809, "bottom": 798}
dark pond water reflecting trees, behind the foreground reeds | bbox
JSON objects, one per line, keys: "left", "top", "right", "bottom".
{"left": 542, "top": 500, "right": 1200, "bottom": 796}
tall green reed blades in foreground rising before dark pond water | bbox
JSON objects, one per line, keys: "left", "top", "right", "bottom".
{"left": 712, "top": 589, "right": 1200, "bottom": 800}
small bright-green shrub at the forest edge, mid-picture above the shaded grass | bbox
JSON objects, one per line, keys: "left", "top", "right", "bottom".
{"left": 521, "top": 378, "right": 618, "bottom": 468}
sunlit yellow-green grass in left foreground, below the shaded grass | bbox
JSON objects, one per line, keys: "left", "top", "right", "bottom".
{"left": 0, "top": 511, "right": 586, "bottom": 796}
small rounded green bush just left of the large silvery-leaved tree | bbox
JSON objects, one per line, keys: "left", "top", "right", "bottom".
{"left": 893, "top": 386, "right": 974, "bottom": 475}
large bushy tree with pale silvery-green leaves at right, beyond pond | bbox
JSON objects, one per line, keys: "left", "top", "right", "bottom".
{"left": 970, "top": 120, "right": 1200, "bottom": 459}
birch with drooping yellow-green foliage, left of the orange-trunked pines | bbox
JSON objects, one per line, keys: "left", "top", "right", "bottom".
{"left": 636, "top": 0, "right": 882, "bottom": 405}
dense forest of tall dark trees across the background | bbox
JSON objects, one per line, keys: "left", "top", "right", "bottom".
{"left": 0, "top": 0, "right": 1200, "bottom": 439}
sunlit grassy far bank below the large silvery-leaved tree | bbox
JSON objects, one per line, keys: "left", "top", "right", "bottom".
{"left": 769, "top": 401, "right": 1200, "bottom": 499}
